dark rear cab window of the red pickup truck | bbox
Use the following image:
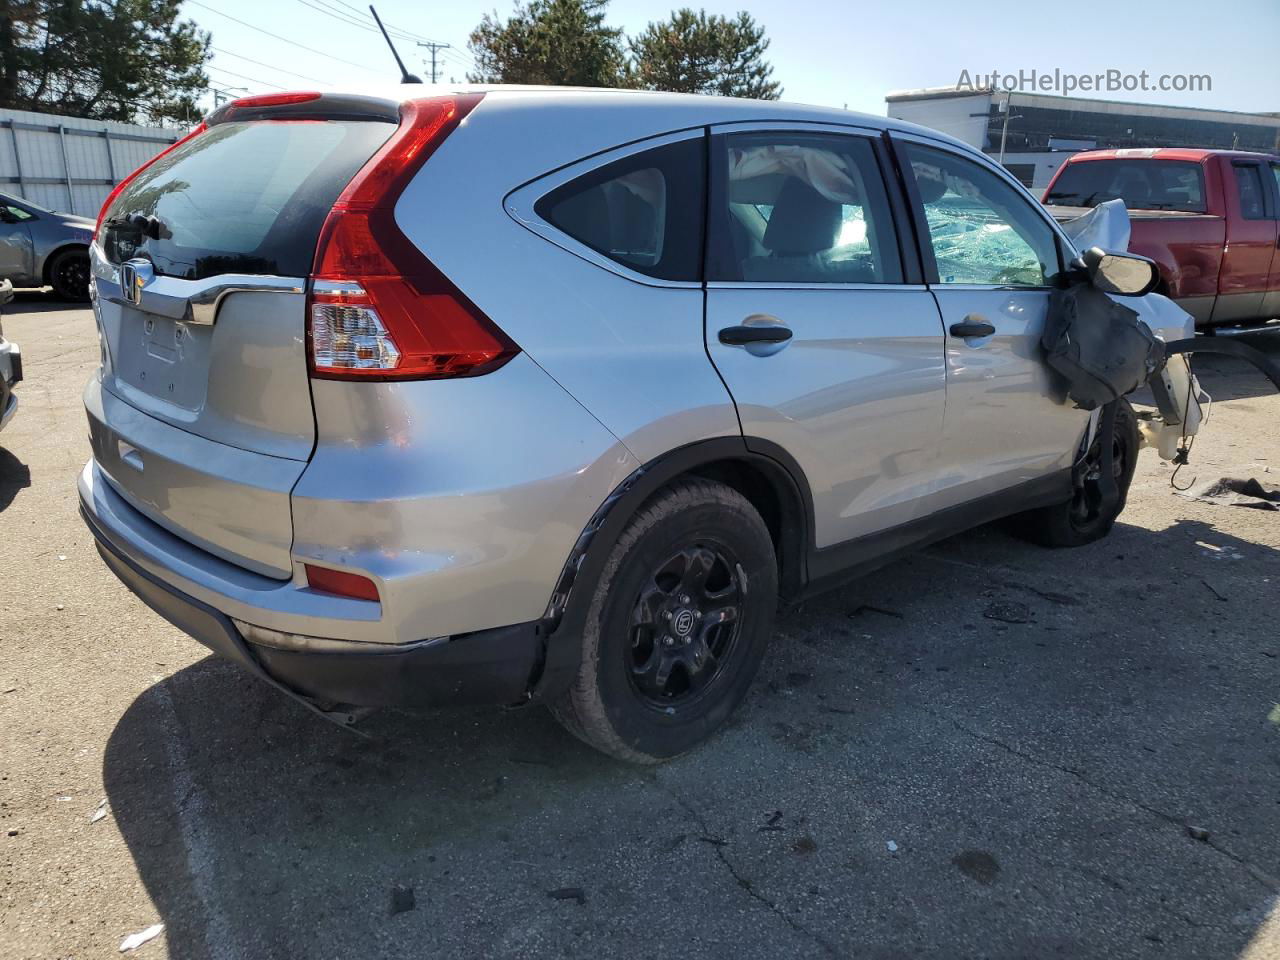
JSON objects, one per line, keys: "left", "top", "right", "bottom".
{"left": 1044, "top": 160, "right": 1206, "bottom": 214}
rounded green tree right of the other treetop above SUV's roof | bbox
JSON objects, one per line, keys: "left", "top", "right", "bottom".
{"left": 631, "top": 6, "right": 782, "bottom": 100}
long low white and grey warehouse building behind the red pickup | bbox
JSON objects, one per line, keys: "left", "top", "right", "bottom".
{"left": 884, "top": 87, "right": 1280, "bottom": 191}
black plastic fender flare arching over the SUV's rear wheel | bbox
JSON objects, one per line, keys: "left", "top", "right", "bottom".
{"left": 529, "top": 436, "right": 814, "bottom": 701}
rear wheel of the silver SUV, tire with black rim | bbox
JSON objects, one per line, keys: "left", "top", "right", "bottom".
{"left": 548, "top": 479, "right": 778, "bottom": 763}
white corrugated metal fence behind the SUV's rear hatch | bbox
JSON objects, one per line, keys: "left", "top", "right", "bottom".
{"left": 0, "top": 110, "right": 184, "bottom": 216}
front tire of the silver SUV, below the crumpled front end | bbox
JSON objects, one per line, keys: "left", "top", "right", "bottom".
{"left": 1010, "top": 397, "right": 1139, "bottom": 547}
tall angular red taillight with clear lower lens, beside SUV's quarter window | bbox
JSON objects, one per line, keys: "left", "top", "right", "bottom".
{"left": 307, "top": 95, "right": 520, "bottom": 380}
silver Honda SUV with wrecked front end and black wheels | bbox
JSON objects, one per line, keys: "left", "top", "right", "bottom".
{"left": 79, "top": 87, "right": 1189, "bottom": 762}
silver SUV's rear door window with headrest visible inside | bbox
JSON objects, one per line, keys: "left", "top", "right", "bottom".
{"left": 707, "top": 133, "right": 902, "bottom": 283}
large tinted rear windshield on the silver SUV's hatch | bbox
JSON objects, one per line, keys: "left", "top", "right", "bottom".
{"left": 104, "top": 120, "right": 396, "bottom": 280}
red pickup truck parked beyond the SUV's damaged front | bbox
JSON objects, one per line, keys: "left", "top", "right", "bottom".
{"left": 1043, "top": 148, "right": 1280, "bottom": 328}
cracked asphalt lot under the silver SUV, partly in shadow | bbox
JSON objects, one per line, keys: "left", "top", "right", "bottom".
{"left": 0, "top": 294, "right": 1280, "bottom": 960}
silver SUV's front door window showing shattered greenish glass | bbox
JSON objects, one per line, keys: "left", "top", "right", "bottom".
{"left": 905, "top": 143, "right": 1059, "bottom": 287}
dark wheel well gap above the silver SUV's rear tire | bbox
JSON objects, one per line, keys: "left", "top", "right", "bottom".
{"left": 673, "top": 457, "right": 808, "bottom": 598}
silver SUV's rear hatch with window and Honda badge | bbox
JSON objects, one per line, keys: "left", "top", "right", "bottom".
{"left": 86, "top": 95, "right": 397, "bottom": 579}
